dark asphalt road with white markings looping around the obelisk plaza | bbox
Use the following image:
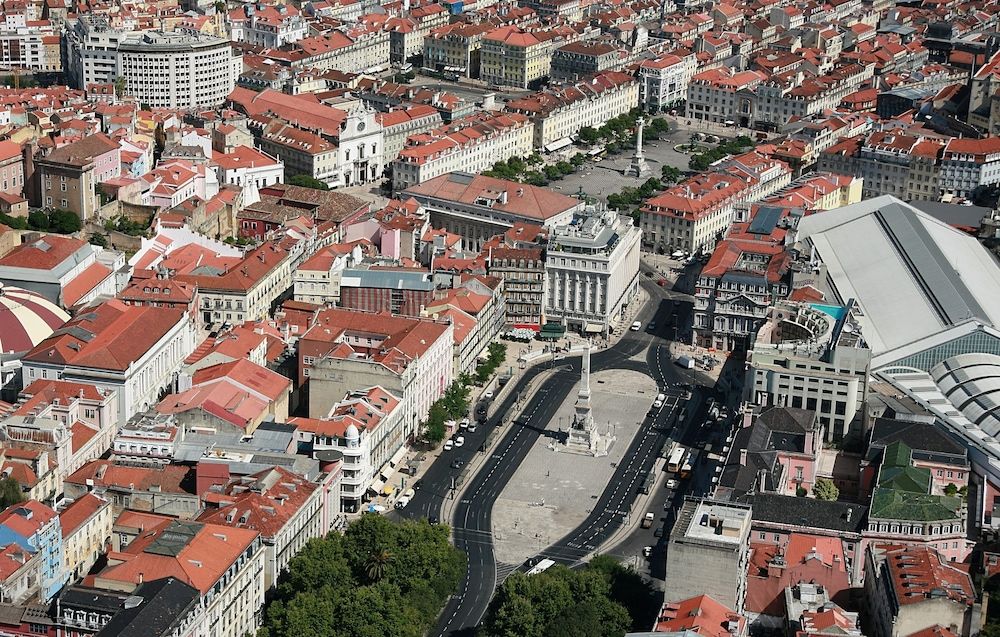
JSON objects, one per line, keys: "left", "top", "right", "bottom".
{"left": 403, "top": 277, "right": 712, "bottom": 635}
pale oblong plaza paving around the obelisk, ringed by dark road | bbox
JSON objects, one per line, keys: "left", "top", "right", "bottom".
{"left": 492, "top": 370, "right": 657, "bottom": 564}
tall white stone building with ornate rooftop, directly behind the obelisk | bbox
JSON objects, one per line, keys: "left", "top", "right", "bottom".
{"left": 545, "top": 210, "right": 642, "bottom": 335}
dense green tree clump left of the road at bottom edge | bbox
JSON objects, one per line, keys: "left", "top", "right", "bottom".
{"left": 258, "top": 515, "right": 465, "bottom": 637}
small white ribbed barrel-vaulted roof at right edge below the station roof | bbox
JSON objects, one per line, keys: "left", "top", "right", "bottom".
{"left": 931, "top": 354, "right": 1000, "bottom": 437}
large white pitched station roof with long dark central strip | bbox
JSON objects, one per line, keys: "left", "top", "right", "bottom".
{"left": 798, "top": 196, "right": 1000, "bottom": 356}
